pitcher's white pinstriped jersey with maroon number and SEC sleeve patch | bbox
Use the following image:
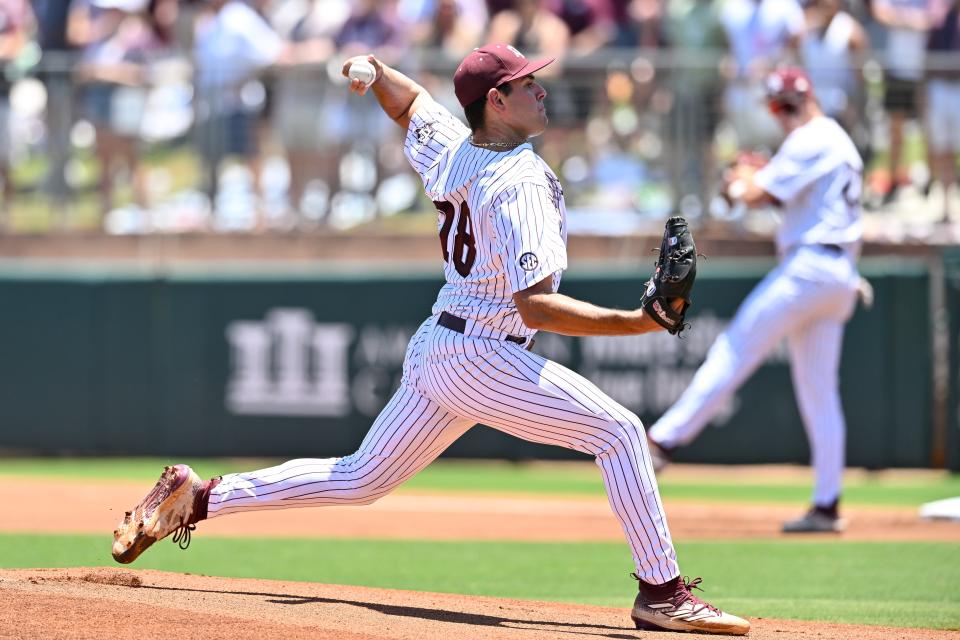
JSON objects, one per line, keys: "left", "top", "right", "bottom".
{"left": 404, "top": 103, "right": 567, "bottom": 338}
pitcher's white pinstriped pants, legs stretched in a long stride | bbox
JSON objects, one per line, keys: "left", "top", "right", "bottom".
{"left": 208, "top": 316, "right": 679, "bottom": 583}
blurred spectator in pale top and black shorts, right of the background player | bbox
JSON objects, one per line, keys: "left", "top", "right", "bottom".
{"left": 872, "top": 0, "right": 930, "bottom": 204}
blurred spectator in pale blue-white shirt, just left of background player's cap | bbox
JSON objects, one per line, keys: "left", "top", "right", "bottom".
{"left": 720, "top": 0, "right": 804, "bottom": 150}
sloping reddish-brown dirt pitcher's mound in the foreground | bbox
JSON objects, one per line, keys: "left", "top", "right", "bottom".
{"left": 0, "top": 568, "right": 949, "bottom": 640}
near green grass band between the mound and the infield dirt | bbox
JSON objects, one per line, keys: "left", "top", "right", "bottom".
{"left": 0, "top": 535, "right": 960, "bottom": 629}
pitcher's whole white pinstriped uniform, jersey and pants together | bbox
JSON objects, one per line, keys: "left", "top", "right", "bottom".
{"left": 208, "top": 97, "right": 679, "bottom": 584}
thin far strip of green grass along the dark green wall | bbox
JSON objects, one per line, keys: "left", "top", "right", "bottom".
{"left": 7, "top": 458, "right": 960, "bottom": 506}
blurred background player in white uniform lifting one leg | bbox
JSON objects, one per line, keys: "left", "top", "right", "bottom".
{"left": 648, "top": 68, "right": 863, "bottom": 532}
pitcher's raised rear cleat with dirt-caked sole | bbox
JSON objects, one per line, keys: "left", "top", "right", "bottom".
{"left": 113, "top": 464, "right": 210, "bottom": 564}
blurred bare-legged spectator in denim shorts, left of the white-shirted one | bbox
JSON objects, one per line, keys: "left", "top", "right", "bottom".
{"left": 70, "top": 0, "right": 164, "bottom": 222}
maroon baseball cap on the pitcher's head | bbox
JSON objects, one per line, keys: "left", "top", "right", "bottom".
{"left": 453, "top": 44, "right": 554, "bottom": 107}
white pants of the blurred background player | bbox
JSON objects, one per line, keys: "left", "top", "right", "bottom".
{"left": 649, "top": 246, "right": 859, "bottom": 505}
